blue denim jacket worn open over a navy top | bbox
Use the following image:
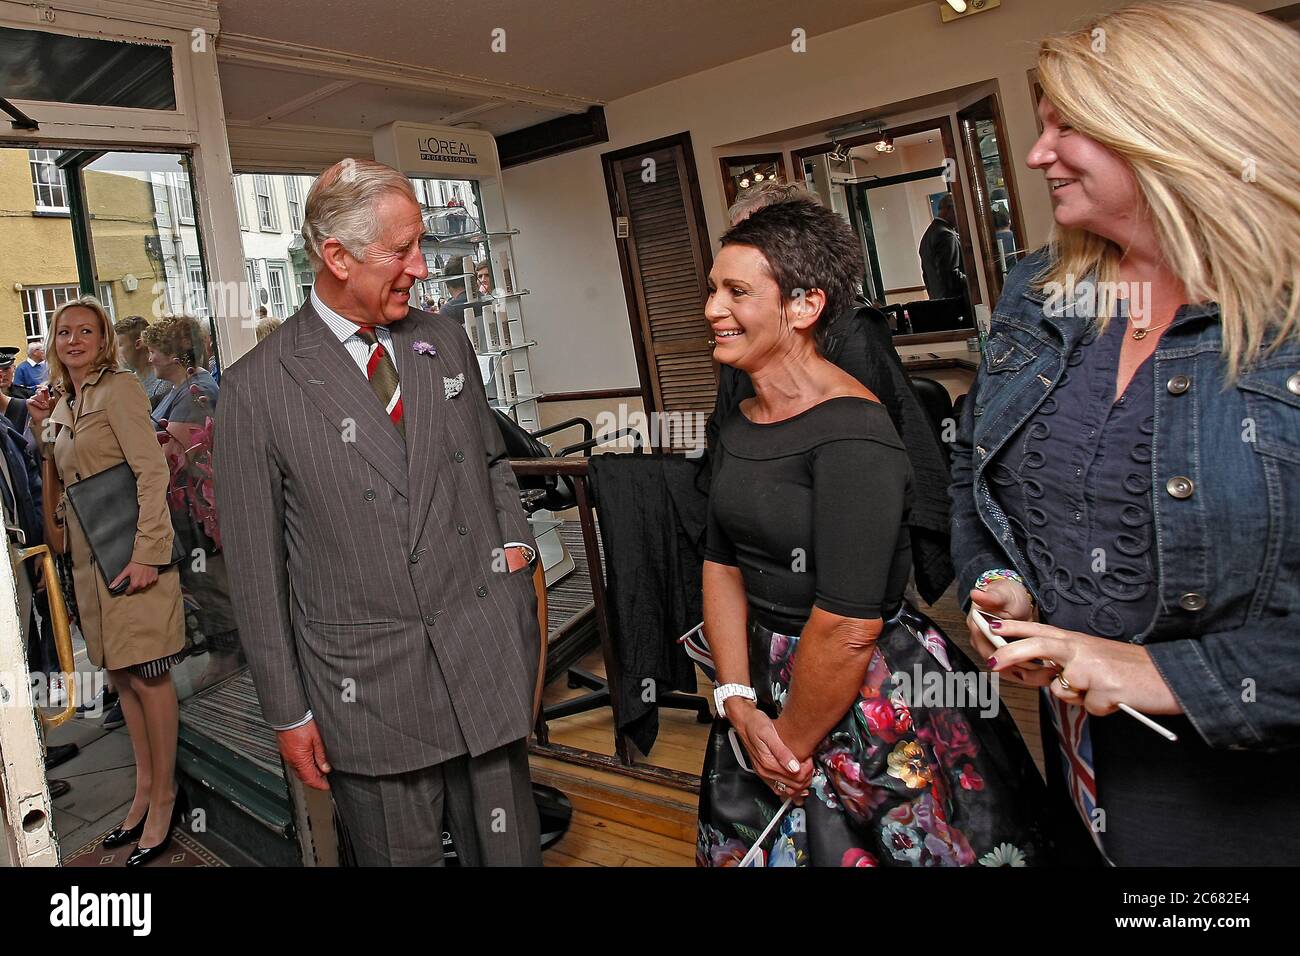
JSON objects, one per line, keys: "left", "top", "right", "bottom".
{"left": 950, "top": 250, "right": 1300, "bottom": 750}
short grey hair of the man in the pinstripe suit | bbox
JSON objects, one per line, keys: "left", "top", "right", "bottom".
{"left": 303, "top": 159, "right": 420, "bottom": 272}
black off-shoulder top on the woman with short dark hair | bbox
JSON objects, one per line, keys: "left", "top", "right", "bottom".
{"left": 705, "top": 395, "right": 911, "bottom": 635}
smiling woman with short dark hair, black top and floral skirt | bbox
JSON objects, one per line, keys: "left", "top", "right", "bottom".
{"left": 697, "top": 203, "right": 1041, "bottom": 866}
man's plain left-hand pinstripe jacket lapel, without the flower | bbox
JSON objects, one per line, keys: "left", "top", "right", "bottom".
{"left": 281, "top": 302, "right": 410, "bottom": 496}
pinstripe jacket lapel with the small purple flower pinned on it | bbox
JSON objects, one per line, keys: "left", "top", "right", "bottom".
{"left": 389, "top": 311, "right": 446, "bottom": 548}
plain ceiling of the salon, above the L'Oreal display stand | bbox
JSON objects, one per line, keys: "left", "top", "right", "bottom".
{"left": 217, "top": 0, "right": 935, "bottom": 135}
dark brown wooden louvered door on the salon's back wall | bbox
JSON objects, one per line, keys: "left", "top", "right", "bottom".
{"left": 603, "top": 133, "right": 718, "bottom": 449}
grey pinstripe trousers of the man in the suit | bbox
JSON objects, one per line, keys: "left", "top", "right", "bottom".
{"left": 329, "top": 740, "right": 542, "bottom": 866}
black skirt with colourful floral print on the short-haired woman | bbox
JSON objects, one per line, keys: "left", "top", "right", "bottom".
{"left": 693, "top": 604, "right": 1045, "bottom": 866}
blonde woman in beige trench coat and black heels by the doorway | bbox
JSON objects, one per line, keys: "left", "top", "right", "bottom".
{"left": 30, "top": 297, "right": 185, "bottom": 866}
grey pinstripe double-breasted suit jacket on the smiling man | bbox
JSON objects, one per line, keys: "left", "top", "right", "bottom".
{"left": 215, "top": 303, "right": 541, "bottom": 775}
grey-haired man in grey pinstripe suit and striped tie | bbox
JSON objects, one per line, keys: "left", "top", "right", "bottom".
{"left": 215, "top": 160, "right": 541, "bottom": 865}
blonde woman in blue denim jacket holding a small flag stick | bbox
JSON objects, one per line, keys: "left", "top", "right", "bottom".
{"left": 953, "top": 0, "right": 1300, "bottom": 865}
